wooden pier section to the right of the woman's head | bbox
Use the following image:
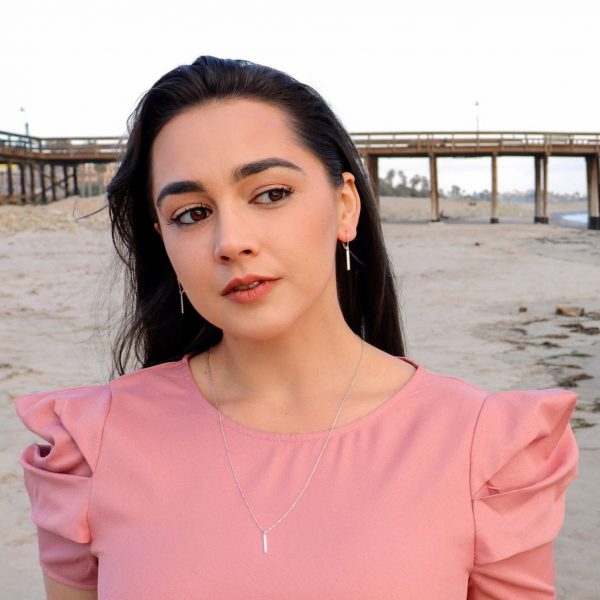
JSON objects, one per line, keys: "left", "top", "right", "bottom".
{"left": 352, "top": 131, "right": 600, "bottom": 229}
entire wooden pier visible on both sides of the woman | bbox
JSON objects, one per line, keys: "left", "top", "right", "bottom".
{"left": 0, "top": 131, "right": 600, "bottom": 229}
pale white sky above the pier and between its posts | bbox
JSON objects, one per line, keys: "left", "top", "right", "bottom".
{"left": 0, "top": 0, "right": 600, "bottom": 193}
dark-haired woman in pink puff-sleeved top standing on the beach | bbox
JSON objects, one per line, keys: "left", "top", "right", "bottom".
{"left": 17, "top": 57, "right": 577, "bottom": 600}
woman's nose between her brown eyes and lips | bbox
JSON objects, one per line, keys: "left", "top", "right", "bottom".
{"left": 214, "top": 209, "right": 258, "bottom": 262}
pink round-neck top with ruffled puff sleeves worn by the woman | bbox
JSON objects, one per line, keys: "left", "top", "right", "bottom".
{"left": 16, "top": 357, "right": 578, "bottom": 600}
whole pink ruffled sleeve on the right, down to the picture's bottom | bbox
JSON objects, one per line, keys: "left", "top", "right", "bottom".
{"left": 468, "top": 389, "right": 578, "bottom": 600}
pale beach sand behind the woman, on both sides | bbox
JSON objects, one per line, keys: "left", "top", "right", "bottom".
{"left": 0, "top": 198, "right": 600, "bottom": 600}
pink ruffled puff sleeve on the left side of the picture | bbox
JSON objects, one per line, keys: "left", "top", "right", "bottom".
{"left": 15, "top": 385, "right": 110, "bottom": 589}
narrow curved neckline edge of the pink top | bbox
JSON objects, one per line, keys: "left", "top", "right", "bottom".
{"left": 180, "top": 354, "right": 425, "bottom": 442}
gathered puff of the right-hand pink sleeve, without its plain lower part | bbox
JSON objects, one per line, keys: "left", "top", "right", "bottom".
{"left": 470, "top": 388, "right": 579, "bottom": 564}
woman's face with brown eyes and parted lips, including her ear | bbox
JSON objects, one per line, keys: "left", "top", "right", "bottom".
{"left": 151, "top": 99, "right": 360, "bottom": 340}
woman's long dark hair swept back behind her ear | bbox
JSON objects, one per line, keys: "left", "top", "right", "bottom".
{"left": 107, "top": 56, "right": 405, "bottom": 374}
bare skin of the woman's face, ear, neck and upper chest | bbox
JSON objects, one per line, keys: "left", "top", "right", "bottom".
{"left": 151, "top": 99, "right": 415, "bottom": 433}
